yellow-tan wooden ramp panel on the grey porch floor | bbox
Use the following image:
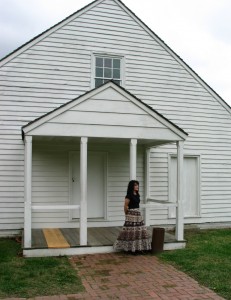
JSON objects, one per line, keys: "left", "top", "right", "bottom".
{"left": 43, "top": 228, "right": 70, "bottom": 248}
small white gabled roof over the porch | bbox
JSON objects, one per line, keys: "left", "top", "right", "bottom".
{"left": 22, "top": 81, "right": 187, "bottom": 143}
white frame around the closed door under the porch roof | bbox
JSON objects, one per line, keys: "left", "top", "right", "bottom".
{"left": 68, "top": 150, "right": 108, "bottom": 222}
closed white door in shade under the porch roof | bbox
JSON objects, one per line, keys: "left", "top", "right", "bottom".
{"left": 70, "top": 152, "right": 106, "bottom": 218}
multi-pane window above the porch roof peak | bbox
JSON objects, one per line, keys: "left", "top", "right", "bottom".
{"left": 95, "top": 56, "right": 122, "bottom": 87}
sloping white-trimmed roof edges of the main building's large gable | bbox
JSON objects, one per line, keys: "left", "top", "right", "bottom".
{"left": 0, "top": 0, "right": 231, "bottom": 113}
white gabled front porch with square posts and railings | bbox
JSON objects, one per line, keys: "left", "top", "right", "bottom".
{"left": 22, "top": 82, "right": 187, "bottom": 255}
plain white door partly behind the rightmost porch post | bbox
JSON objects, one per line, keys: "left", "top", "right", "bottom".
{"left": 169, "top": 156, "right": 200, "bottom": 218}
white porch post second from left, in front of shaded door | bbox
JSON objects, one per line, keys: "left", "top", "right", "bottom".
{"left": 80, "top": 137, "right": 88, "bottom": 246}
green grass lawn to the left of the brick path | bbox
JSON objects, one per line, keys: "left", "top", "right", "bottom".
{"left": 0, "top": 238, "right": 84, "bottom": 298}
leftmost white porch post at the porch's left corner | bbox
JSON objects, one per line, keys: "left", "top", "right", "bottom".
{"left": 24, "top": 136, "right": 32, "bottom": 248}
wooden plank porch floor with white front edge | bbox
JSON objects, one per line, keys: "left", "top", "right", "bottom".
{"left": 22, "top": 226, "right": 186, "bottom": 257}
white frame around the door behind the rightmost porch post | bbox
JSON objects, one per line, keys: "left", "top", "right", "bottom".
{"left": 168, "top": 153, "right": 201, "bottom": 219}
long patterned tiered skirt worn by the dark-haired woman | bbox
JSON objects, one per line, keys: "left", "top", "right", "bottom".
{"left": 114, "top": 209, "right": 151, "bottom": 252}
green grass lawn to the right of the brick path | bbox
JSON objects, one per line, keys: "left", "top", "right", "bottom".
{"left": 159, "top": 229, "right": 231, "bottom": 300}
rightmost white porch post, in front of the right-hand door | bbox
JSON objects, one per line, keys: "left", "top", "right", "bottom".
{"left": 175, "top": 141, "right": 184, "bottom": 241}
